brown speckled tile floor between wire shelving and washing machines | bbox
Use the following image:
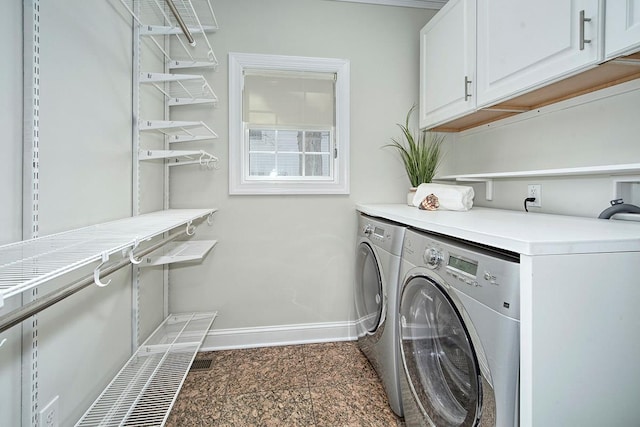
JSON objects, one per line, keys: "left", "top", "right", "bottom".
{"left": 167, "top": 342, "right": 404, "bottom": 427}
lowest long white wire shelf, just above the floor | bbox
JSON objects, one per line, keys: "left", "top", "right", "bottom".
{"left": 76, "top": 312, "right": 217, "bottom": 427}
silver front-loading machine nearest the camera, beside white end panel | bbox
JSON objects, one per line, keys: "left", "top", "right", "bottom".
{"left": 399, "top": 230, "right": 520, "bottom": 427}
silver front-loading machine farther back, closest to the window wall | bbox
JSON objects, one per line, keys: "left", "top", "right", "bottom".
{"left": 354, "top": 214, "right": 406, "bottom": 416}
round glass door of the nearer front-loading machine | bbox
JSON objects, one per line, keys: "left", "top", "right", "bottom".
{"left": 400, "top": 276, "right": 481, "bottom": 427}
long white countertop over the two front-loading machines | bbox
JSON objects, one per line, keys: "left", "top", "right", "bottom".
{"left": 356, "top": 204, "right": 640, "bottom": 260}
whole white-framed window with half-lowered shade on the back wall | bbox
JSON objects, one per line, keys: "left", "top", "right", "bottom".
{"left": 229, "top": 53, "right": 349, "bottom": 194}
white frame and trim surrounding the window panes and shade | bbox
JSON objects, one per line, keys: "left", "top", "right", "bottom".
{"left": 229, "top": 52, "right": 349, "bottom": 195}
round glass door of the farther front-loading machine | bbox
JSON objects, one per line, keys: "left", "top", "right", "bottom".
{"left": 355, "top": 243, "right": 383, "bottom": 334}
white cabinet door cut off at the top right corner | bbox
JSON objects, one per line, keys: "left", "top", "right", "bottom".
{"left": 604, "top": 0, "right": 640, "bottom": 59}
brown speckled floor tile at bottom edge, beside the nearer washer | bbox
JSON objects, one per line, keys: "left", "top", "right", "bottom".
{"left": 311, "top": 382, "right": 399, "bottom": 427}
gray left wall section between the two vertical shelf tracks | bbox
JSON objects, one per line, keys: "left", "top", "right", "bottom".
{"left": 38, "top": 0, "right": 131, "bottom": 425}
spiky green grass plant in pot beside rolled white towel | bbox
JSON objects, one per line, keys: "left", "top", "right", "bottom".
{"left": 385, "top": 105, "right": 444, "bottom": 204}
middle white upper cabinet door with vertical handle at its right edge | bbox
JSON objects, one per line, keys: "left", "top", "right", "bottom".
{"left": 476, "top": 0, "right": 603, "bottom": 107}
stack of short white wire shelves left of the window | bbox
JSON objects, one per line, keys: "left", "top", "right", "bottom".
{"left": 120, "top": 0, "right": 218, "bottom": 168}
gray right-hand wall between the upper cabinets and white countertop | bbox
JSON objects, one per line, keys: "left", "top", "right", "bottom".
{"left": 442, "top": 81, "right": 640, "bottom": 217}
